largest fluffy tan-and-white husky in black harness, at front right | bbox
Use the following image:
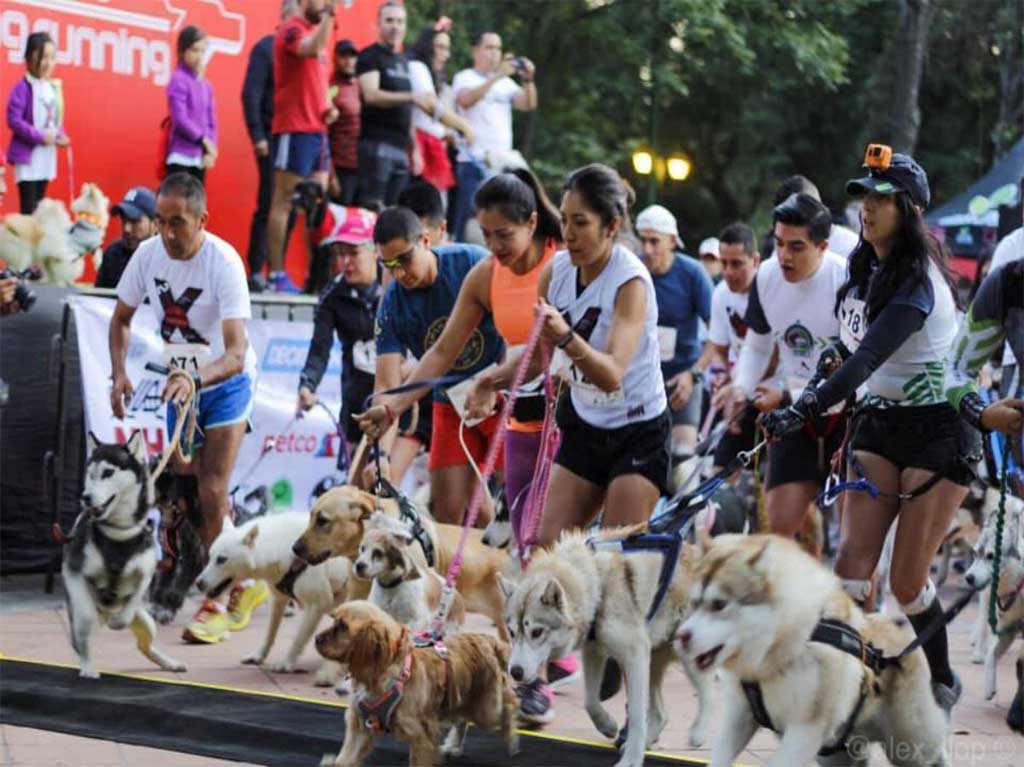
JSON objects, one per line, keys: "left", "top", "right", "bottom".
{"left": 679, "top": 536, "right": 948, "bottom": 767}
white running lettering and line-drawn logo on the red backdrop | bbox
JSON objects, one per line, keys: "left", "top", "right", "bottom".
{"left": 0, "top": 0, "right": 246, "bottom": 86}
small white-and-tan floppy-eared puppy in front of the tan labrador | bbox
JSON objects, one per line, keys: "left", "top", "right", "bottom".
{"left": 352, "top": 528, "right": 466, "bottom": 636}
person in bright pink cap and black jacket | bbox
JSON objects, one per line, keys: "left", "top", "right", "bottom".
{"left": 298, "top": 205, "right": 381, "bottom": 460}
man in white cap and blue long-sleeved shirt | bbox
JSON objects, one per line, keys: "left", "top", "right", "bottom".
{"left": 636, "top": 205, "right": 714, "bottom": 464}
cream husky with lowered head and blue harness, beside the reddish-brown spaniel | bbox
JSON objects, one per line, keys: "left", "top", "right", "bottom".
{"left": 502, "top": 525, "right": 711, "bottom": 767}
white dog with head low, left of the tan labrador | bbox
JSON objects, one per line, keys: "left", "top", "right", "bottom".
{"left": 196, "top": 511, "right": 349, "bottom": 686}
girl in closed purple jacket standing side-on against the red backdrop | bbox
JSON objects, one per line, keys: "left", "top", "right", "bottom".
{"left": 165, "top": 26, "right": 217, "bottom": 181}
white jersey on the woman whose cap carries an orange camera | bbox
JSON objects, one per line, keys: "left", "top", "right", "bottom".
{"left": 840, "top": 261, "right": 957, "bottom": 407}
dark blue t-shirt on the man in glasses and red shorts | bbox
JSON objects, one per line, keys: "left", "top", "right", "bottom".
{"left": 376, "top": 245, "right": 505, "bottom": 402}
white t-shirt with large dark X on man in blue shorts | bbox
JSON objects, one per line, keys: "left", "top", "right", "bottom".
{"left": 118, "top": 231, "right": 256, "bottom": 388}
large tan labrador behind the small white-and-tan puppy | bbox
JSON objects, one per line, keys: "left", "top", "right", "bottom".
{"left": 292, "top": 484, "right": 508, "bottom": 641}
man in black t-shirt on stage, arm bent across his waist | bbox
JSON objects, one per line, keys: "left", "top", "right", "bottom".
{"left": 355, "top": 0, "right": 435, "bottom": 210}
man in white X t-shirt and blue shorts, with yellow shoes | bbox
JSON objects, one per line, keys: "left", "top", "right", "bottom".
{"left": 110, "top": 173, "right": 260, "bottom": 642}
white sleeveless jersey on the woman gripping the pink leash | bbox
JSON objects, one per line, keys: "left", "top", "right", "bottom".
{"left": 548, "top": 245, "right": 668, "bottom": 429}
